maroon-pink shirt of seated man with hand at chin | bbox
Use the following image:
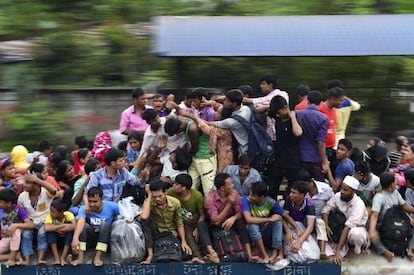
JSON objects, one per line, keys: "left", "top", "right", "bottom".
{"left": 204, "top": 190, "right": 242, "bottom": 223}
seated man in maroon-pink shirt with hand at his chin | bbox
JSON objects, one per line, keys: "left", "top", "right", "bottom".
{"left": 204, "top": 173, "right": 257, "bottom": 262}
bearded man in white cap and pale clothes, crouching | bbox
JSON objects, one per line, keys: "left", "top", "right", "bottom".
{"left": 322, "top": 176, "right": 370, "bottom": 265}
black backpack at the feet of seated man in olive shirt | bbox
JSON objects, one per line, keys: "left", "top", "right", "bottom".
{"left": 152, "top": 231, "right": 182, "bottom": 263}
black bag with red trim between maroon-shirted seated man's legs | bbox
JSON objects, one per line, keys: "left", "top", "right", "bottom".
{"left": 213, "top": 229, "right": 248, "bottom": 262}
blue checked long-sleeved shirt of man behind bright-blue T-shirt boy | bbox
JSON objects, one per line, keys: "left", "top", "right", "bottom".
{"left": 85, "top": 167, "right": 139, "bottom": 202}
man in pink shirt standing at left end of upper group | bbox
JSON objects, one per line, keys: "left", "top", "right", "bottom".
{"left": 119, "top": 88, "right": 152, "bottom": 135}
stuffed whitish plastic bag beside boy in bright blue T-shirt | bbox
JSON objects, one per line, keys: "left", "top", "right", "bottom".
{"left": 111, "top": 197, "right": 146, "bottom": 264}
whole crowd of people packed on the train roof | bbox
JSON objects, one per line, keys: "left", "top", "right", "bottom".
{"left": 0, "top": 74, "right": 414, "bottom": 267}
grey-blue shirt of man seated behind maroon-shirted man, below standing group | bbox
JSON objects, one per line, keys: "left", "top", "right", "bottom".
{"left": 223, "top": 165, "right": 262, "bottom": 197}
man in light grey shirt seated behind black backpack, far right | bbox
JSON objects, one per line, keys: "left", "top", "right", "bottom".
{"left": 369, "top": 172, "right": 414, "bottom": 262}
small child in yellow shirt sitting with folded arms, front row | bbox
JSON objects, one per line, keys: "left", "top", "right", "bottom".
{"left": 45, "top": 199, "right": 76, "bottom": 266}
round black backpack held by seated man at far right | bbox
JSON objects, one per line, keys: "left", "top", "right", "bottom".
{"left": 380, "top": 205, "right": 411, "bottom": 256}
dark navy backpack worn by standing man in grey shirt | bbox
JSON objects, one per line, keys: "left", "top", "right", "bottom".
{"left": 232, "top": 114, "right": 274, "bottom": 175}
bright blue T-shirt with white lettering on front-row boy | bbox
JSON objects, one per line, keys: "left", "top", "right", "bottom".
{"left": 77, "top": 201, "right": 119, "bottom": 232}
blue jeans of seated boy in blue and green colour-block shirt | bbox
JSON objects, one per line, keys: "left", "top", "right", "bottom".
{"left": 247, "top": 221, "right": 283, "bottom": 249}
